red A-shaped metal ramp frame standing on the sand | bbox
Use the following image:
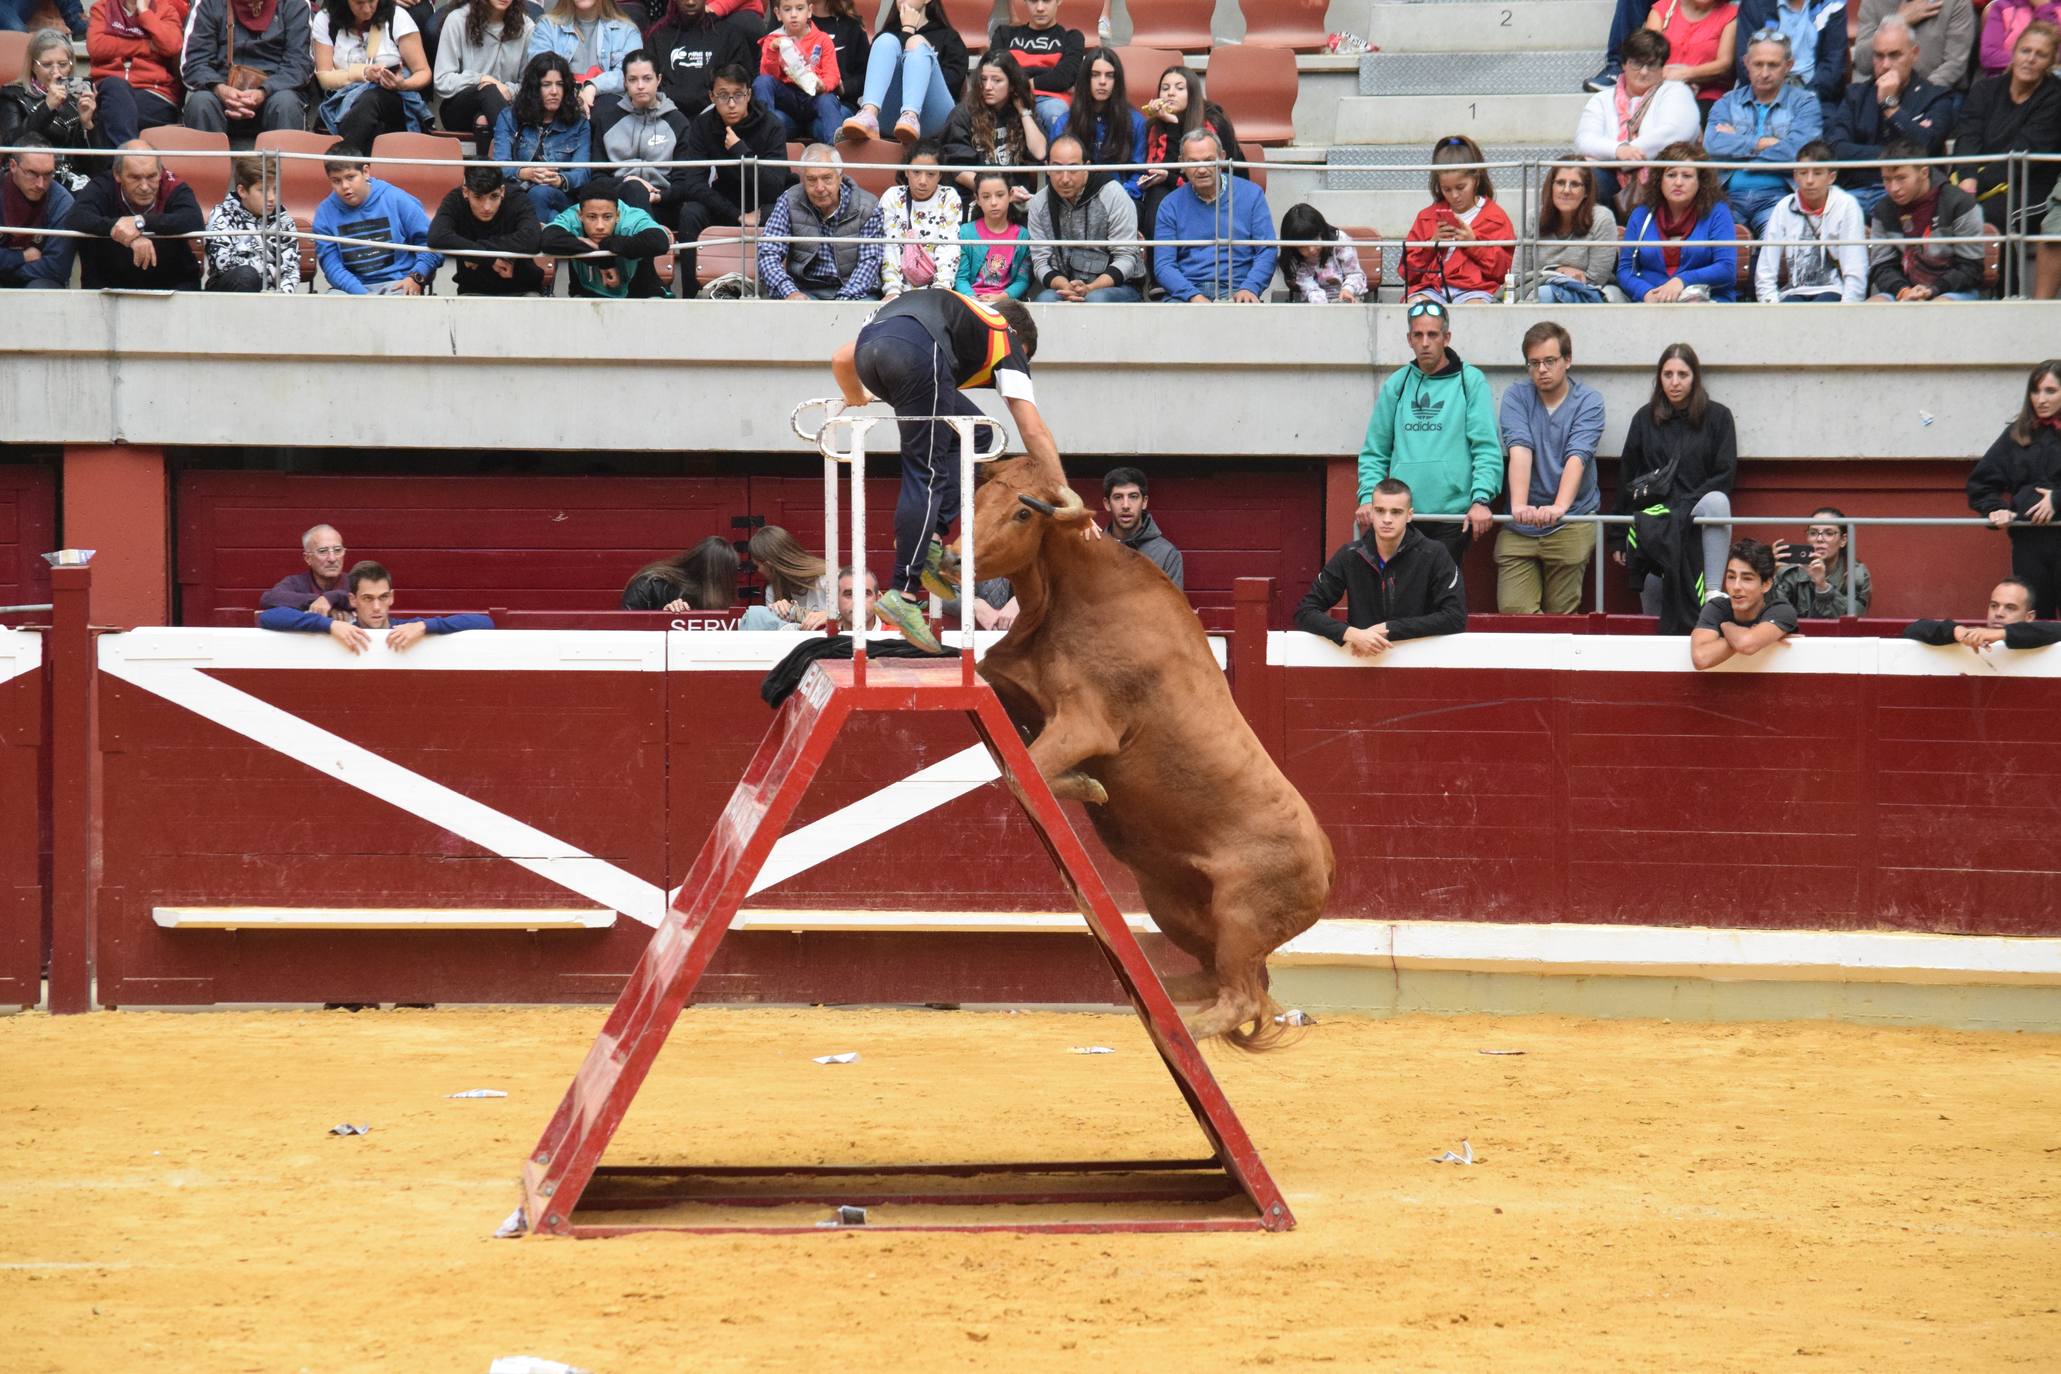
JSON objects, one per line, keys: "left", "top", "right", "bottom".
{"left": 523, "top": 657, "right": 1294, "bottom": 1236}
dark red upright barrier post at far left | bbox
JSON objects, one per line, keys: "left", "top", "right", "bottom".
{"left": 47, "top": 556, "right": 99, "bottom": 1016}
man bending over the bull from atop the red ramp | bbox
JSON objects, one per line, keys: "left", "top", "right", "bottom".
{"left": 831, "top": 290, "right": 1059, "bottom": 653}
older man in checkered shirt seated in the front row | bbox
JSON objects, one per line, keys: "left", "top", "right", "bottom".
{"left": 758, "top": 142, "right": 882, "bottom": 301}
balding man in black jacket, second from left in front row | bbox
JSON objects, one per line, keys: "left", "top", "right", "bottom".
{"left": 64, "top": 142, "right": 202, "bottom": 290}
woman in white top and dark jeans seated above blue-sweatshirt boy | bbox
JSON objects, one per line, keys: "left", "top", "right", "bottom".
{"left": 309, "top": 0, "right": 431, "bottom": 148}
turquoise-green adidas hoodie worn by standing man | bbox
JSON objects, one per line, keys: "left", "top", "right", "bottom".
{"left": 1360, "top": 348, "right": 1502, "bottom": 515}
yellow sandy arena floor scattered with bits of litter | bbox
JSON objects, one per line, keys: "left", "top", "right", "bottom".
{"left": 0, "top": 1007, "right": 2061, "bottom": 1374}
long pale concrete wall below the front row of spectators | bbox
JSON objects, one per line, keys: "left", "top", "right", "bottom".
{"left": 0, "top": 293, "right": 2061, "bottom": 459}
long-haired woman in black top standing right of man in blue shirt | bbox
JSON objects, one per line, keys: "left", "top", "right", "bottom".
{"left": 1610, "top": 344, "right": 1739, "bottom": 616}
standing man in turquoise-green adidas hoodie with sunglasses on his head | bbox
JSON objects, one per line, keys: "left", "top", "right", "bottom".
{"left": 1354, "top": 301, "right": 1502, "bottom": 564}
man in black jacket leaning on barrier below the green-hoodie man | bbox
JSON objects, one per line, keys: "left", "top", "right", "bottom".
{"left": 1294, "top": 478, "right": 1467, "bottom": 659}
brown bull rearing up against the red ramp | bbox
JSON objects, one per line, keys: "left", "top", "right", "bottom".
{"left": 973, "top": 457, "right": 1333, "bottom": 1049}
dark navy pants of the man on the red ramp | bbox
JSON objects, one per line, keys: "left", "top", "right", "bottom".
{"left": 855, "top": 317, "right": 981, "bottom": 593}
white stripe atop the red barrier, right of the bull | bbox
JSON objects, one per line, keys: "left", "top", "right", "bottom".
{"left": 1268, "top": 630, "right": 2061, "bottom": 678}
